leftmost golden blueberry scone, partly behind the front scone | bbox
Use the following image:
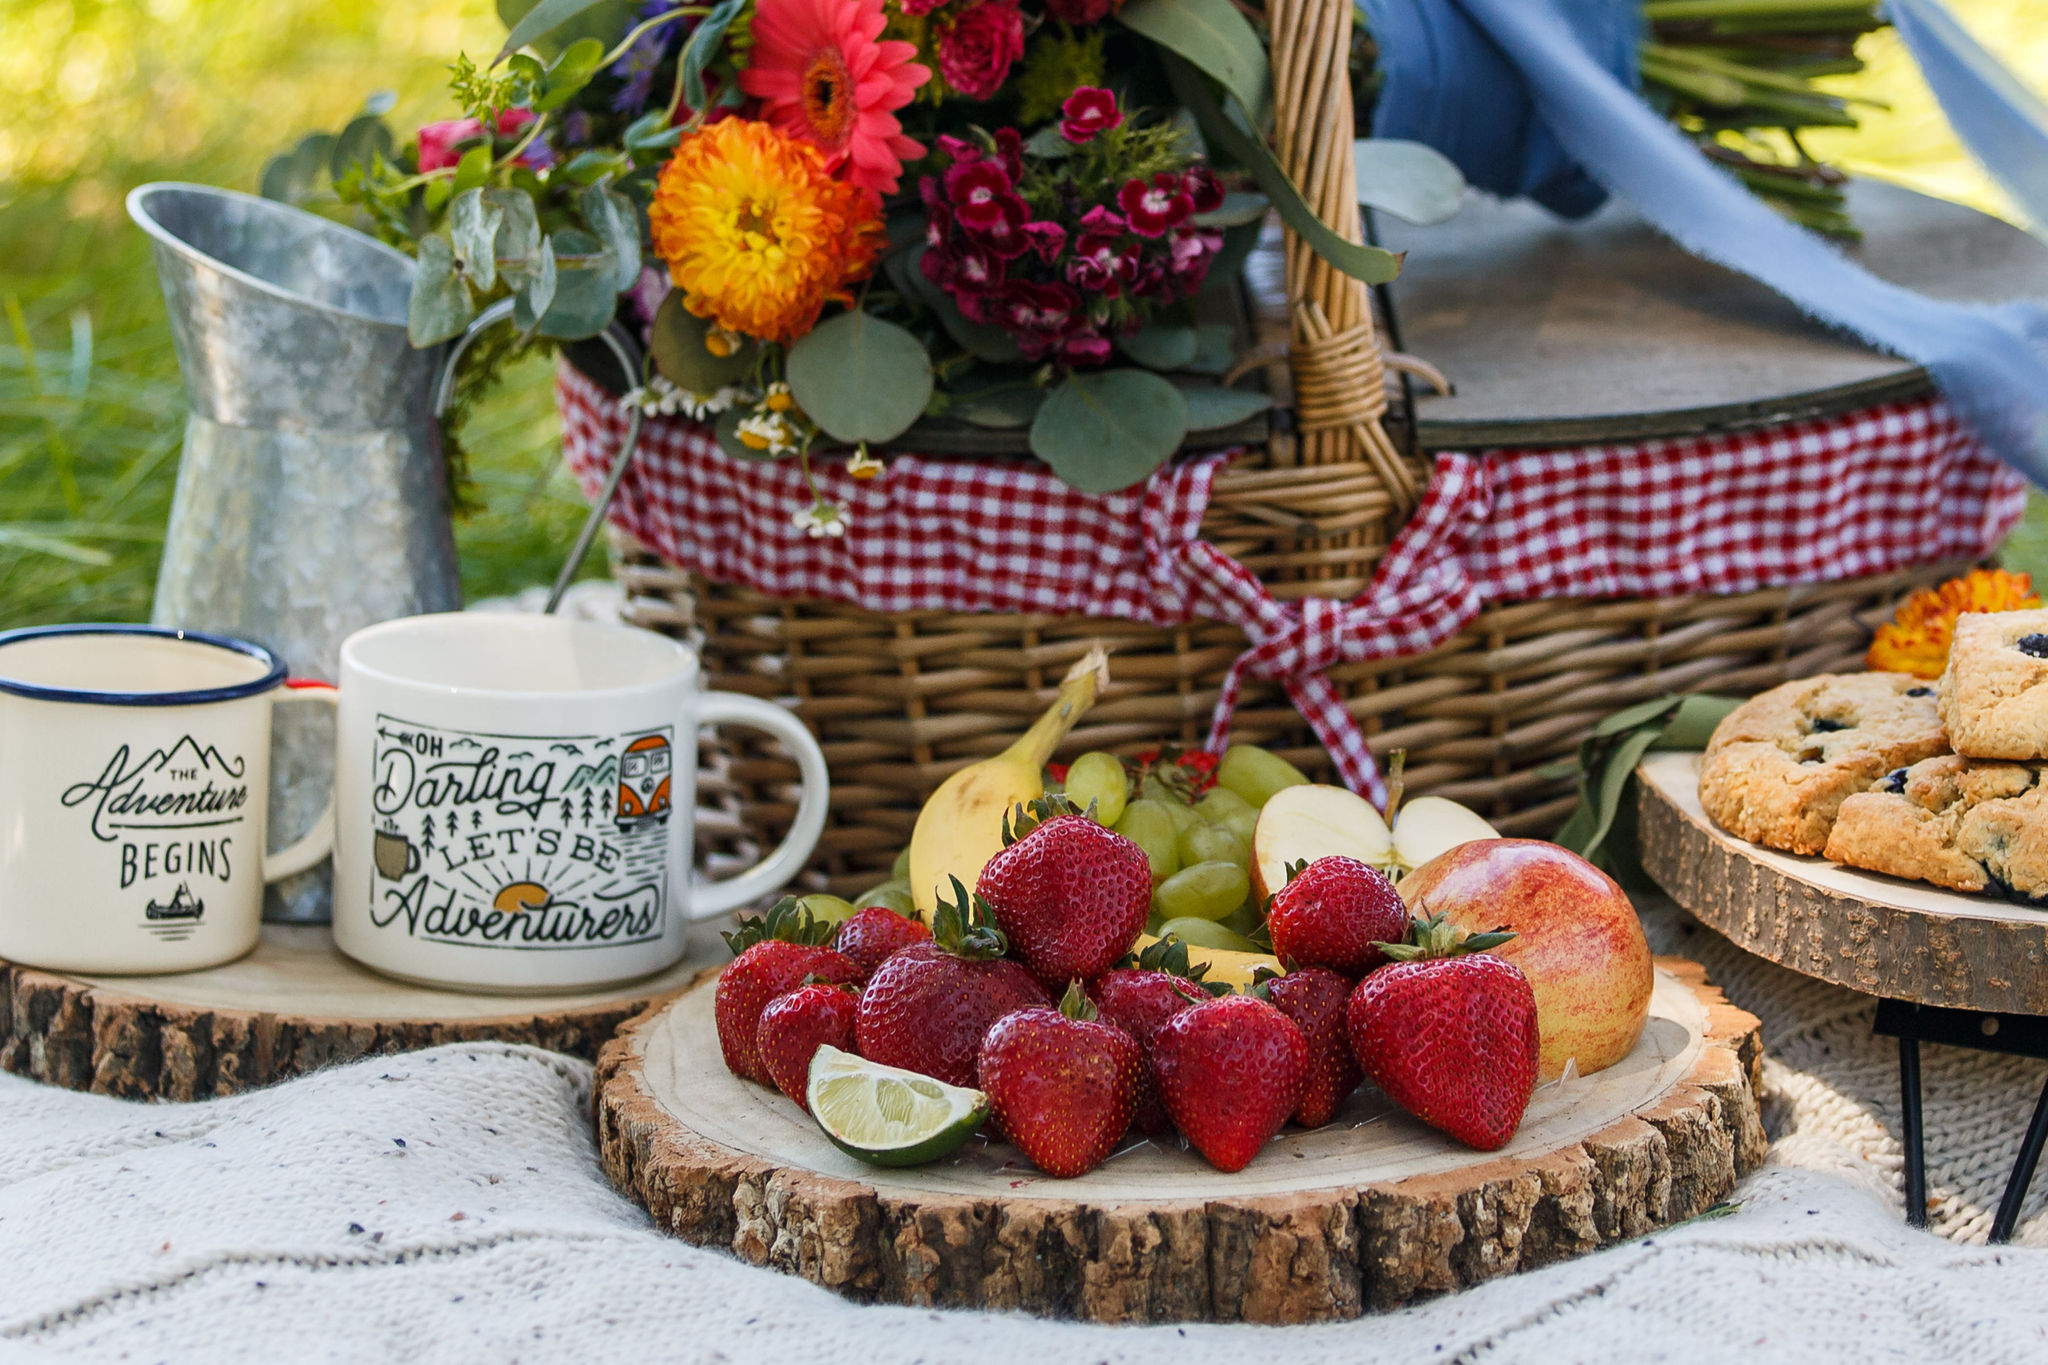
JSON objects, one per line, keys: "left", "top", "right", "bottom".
{"left": 1700, "top": 673, "right": 1948, "bottom": 853}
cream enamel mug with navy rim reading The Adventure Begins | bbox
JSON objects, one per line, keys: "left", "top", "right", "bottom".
{"left": 0, "top": 626, "right": 334, "bottom": 972}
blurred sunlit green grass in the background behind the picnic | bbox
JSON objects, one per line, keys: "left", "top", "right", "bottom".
{"left": 0, "top": 0, "right": 2048, "bottom": 626}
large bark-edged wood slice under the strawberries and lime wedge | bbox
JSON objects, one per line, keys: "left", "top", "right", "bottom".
{"left": 596, "top": 960, "right": 1765, "bottom": 1322}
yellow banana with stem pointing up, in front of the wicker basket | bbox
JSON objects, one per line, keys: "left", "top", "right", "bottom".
{"left": 909, "top": 645, "right": 1110, "bottom": 921}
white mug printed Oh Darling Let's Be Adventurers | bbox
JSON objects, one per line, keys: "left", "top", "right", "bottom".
{"left": 334, "top": 612, "right": 829, "bottom": 993}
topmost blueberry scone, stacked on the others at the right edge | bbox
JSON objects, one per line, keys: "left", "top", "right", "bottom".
{"left": 1939, "top": 610, "right": 2048, "bottom": 759}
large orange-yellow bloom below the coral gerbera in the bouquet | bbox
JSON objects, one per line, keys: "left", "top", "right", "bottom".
{"left": 647, "top": 119, "right": 885, "bottom": 342}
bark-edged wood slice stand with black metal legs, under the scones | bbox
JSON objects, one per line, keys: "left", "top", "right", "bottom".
{"left": 1636, "top": 753, "right": 2048, "bottom": 1242}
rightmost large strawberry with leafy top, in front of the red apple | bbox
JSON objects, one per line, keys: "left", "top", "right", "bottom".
{"left": 1343, "top": 915, "right": 1540, "bottom": 1152}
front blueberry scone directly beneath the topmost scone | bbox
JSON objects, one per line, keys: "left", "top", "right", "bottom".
{"left": 1827, "top": 753, "right": 2048, "bottom": 900}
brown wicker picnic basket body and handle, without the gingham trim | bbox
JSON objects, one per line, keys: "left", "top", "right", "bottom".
{"left": 593, "top": 0, "right": 1964, "bottom": 894}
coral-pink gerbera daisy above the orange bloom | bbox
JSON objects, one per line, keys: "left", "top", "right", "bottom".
{"left": 739, "top": 0, "right": 932, "bottom": 199}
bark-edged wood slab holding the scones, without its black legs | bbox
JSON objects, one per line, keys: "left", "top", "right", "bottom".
{"left": 1636, "top": 753, "right": 2048, "bottom": 1015}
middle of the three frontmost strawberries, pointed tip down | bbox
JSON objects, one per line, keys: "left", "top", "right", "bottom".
{"left": 1153, "top": 995, "right": 1309, "bottom": 1171}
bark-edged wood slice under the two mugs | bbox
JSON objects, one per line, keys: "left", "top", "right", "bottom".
{"left": 0, "top": 925, "right": 709, "bottom": 1099}
